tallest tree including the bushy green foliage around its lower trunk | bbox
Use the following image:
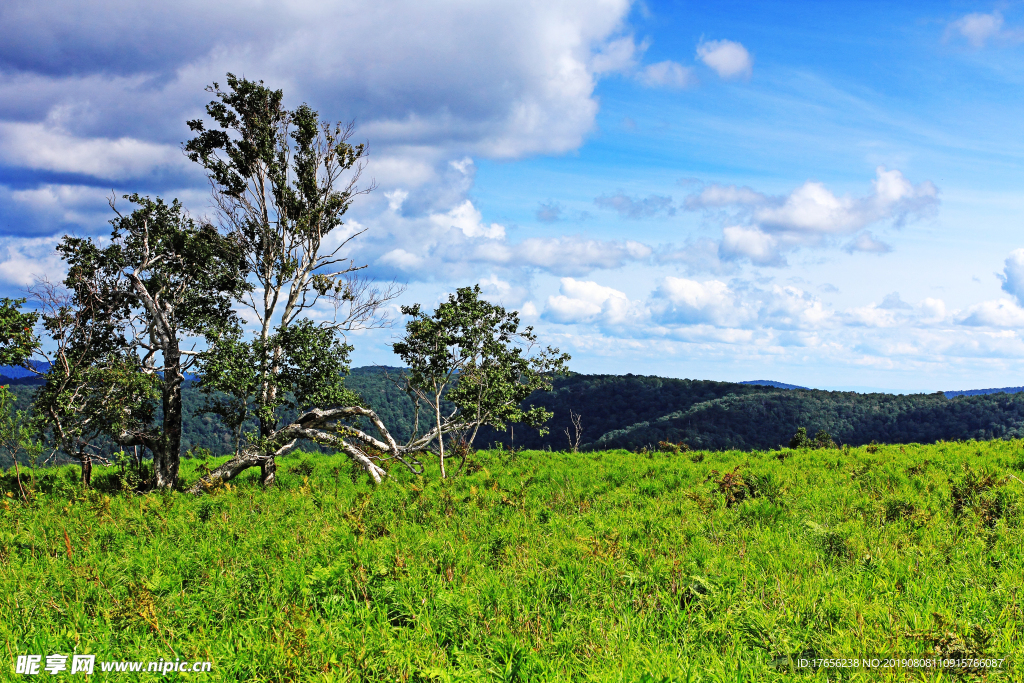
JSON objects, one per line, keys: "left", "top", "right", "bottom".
{"left": 184, "top": 74, "right": 380, "bottom": 475}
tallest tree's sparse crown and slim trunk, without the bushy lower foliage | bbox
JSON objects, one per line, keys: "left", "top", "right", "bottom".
{"left": 184, "top": 74, "right": 401, "bottom": 485}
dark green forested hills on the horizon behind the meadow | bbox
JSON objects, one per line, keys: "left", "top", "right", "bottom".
{"left": 6, "top": 367, "right": 1024, "bottom": 454}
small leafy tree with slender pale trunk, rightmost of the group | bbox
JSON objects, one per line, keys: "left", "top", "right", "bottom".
{"left": 393, "top": 285, "right": 569, "bottom": 477}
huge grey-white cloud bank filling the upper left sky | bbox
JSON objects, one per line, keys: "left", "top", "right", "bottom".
{"left": 0, "top": 0, "right": 644, "bottom": 270}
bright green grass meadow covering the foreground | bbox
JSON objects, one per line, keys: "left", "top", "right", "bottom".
{"left": 0, "top": 441, "right": 1024, "bottom": 682}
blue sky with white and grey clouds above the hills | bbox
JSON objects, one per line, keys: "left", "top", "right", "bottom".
{"left": 0, "top": 0, "right": 1024, "bottom": 393}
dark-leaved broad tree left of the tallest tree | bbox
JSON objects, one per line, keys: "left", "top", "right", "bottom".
{"left": 37, "top": 195, "right": 247, "bottom": 488}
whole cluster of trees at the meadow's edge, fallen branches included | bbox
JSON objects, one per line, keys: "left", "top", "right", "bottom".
{"left": 0, "top": 74, "right": 568, "bottom": 493}
